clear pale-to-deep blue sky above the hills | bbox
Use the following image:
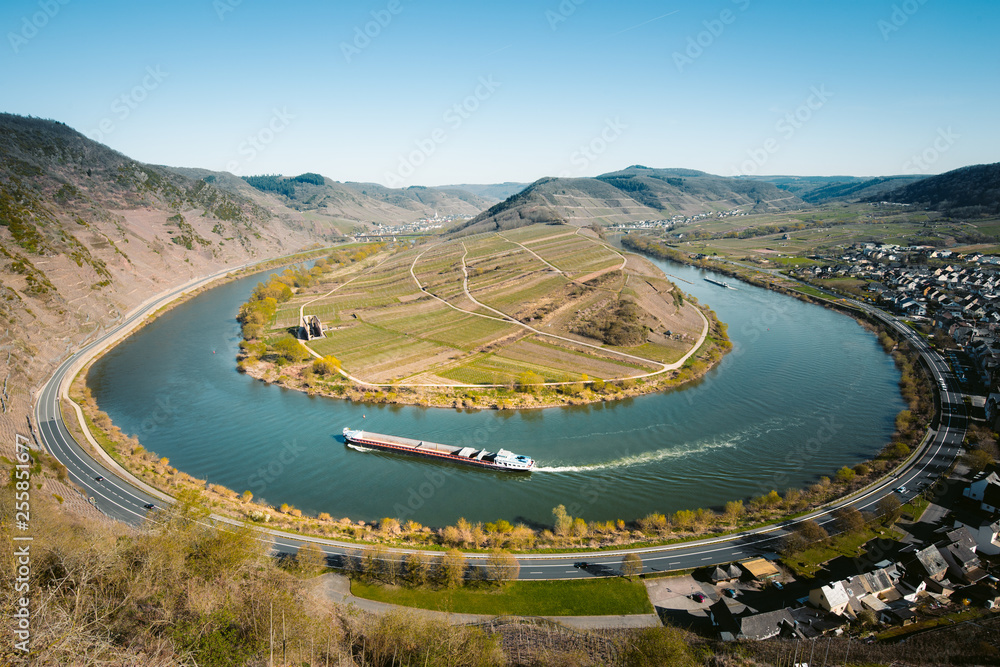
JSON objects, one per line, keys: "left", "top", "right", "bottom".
{"left": 0, "top": 0, "right": 1000, "bottom": 186}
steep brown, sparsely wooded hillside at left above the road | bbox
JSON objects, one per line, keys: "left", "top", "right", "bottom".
{"left": 0, "top": 114, "right": 338, "bottom": 474}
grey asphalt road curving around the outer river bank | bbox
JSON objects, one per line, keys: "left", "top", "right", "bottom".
{"left": 34, "top": 267, "right": 967, "bottom": 579}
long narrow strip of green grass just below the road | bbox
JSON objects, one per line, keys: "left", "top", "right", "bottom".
{"left": 351, "top": 579, "right": 654, "bottom": 616}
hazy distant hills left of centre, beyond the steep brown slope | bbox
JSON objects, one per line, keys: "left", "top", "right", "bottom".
{"left": 196, "top": 169, "right": 495, "bottom": 233}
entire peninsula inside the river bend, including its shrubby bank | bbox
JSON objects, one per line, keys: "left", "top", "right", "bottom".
{"left": 232, "top": 225, "right": 730, "bottom": 409}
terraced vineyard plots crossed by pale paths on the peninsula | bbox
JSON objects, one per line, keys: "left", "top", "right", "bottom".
{"left": 273, "top": 225, "right": 707, "bottom": 387}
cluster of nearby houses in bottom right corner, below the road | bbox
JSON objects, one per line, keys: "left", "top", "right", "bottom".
{"left": 647, "top": 456, "right": 1000, "bottom": 640}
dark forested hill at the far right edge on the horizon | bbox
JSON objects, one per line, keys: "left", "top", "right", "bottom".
{"left": 865, "top": 162, "right": 1000, "bottom": 218}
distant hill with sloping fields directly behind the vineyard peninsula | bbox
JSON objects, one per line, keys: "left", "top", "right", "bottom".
{"left": 453, "top": 166, "right": 804, "bottom": 234}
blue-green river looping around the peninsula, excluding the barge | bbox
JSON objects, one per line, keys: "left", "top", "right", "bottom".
{"left": 88, "top": 250, "right": 905, "bottom": 526}
